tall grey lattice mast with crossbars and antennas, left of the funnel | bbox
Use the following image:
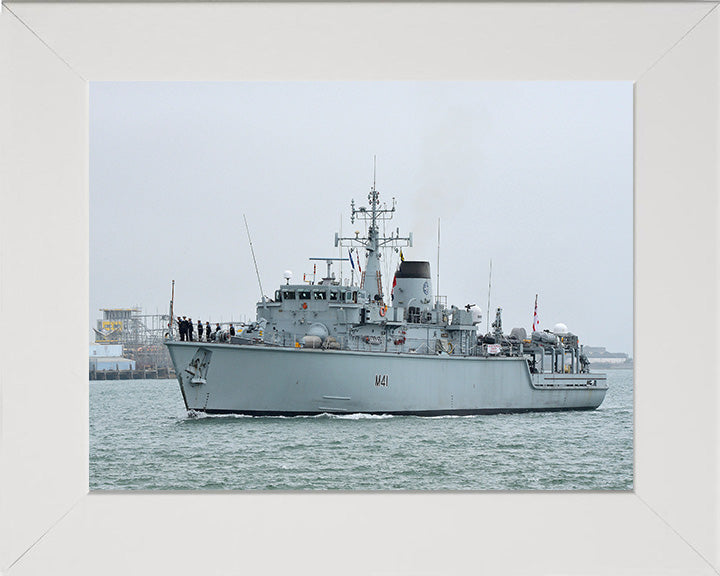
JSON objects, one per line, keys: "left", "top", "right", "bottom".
{"left": 335, "top": 183, "right": 412, "bottom": 303}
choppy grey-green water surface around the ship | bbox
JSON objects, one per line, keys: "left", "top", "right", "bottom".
{"left": 90, "top": 370, "right": 633, "bottom": 490}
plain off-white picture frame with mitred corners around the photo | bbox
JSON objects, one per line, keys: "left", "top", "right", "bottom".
{"left": 0, "top": 2, "right": 720, "bottom": 576}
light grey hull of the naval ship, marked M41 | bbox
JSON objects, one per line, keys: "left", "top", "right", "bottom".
{"left": 167, "top": 342, "right": 607, "bottom": 416}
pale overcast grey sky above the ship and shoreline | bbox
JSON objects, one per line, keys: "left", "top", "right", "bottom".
{"left": 90, "top": 82, "right": 633, "bottom": 354}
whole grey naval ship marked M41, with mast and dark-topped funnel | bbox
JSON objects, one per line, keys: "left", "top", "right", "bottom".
{"left": 166, "top": 185, "right": 607, "bottom": 416}
